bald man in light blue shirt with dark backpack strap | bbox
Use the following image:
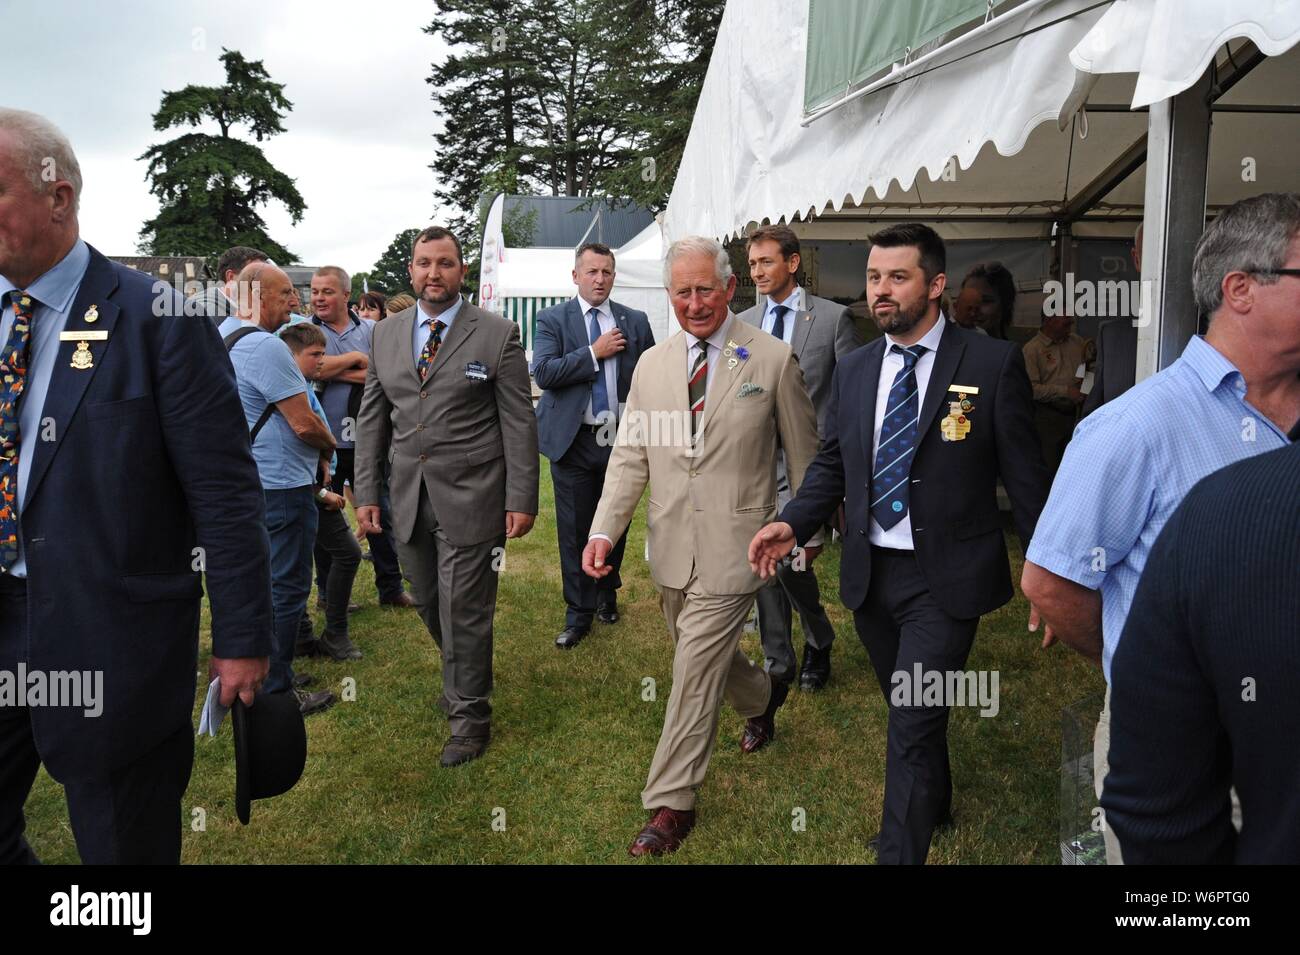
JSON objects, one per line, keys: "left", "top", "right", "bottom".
{"left": 218, "top": 262, "right": 334, "bottom": 715}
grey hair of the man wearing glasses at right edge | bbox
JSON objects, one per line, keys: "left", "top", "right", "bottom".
{"left": 1192, "top": 192, "right": 1300, "bottom": 317}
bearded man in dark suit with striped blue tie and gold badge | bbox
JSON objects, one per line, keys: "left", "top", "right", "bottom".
{"left": 750, "top": 223, "right": 1048, "bottom": 864}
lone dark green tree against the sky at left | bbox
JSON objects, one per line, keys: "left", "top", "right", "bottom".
{"left": 139, "top": 49, "right": 307, "bottom": 265}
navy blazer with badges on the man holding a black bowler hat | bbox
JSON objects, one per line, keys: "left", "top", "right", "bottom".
{"left": 21, "top": 249, "right": 272, "bottom": 780}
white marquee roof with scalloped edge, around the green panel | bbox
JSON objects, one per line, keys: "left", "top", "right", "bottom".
{"left": 663, "top": 0, "right": 1300, "bottom": 240}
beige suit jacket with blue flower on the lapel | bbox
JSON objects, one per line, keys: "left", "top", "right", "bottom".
{"left": 592, "top": 316, "right": 818, "bottom": 594}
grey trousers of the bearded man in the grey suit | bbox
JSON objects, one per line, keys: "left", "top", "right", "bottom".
{"left": 397, "top": 487, "right": 506, "bottom": 737}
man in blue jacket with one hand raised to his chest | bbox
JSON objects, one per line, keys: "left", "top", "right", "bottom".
{"left": 533, "top": 242, "right": 654, "bottom": 650}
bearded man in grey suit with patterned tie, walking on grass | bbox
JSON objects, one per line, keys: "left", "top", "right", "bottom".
{"left": 352, "top": 226, "right": 538, "bottom": 767}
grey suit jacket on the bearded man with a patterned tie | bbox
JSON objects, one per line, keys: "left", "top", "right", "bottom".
{"left": 352, "top": 301, "right": 538, "bottom": 547}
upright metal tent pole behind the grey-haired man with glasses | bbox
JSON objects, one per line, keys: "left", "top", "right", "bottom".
{"left": 1138, "top": 64, "right": 1213, "bottom": 381}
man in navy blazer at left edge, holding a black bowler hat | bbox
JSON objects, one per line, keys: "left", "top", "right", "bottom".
{"left": 0, "top": 109, "right": 272, "bottom": 864}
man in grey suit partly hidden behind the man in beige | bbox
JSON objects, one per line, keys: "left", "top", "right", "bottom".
{"left": 740, "top": 225, "right": 862, "bottom": 690}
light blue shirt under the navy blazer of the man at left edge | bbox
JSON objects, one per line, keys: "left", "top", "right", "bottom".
{"left": 0, "top": 239, "right": 90, "bottom": 577}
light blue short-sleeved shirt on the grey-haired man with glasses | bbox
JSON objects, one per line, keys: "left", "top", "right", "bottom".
{"left": 1026, "top": 335, "right": 1288, "bottom": 682}
